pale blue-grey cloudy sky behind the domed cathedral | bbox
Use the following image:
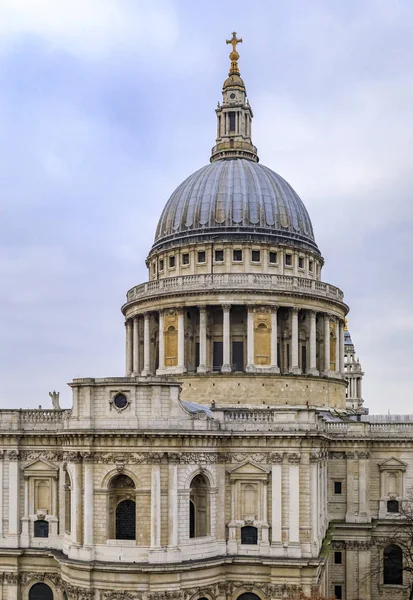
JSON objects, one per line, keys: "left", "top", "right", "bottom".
{"left": 0, "top": 0, "right": 413, "bottom": 413}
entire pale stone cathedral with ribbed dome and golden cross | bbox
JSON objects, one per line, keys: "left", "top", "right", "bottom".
{"left": 0, "top": 34, "right": 413, "bottom": 600}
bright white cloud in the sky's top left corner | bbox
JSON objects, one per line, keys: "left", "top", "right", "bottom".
{"left": 0, "top": 0, "right": 178, "bottom": 58}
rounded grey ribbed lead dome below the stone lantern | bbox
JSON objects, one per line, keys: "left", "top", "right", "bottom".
{"left": 153, "top": 158, "right": 319, "bottom": 254}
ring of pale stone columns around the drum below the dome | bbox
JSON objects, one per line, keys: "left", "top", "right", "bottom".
{"left": 126, "top": 303, "right": 344, "bottom": 378}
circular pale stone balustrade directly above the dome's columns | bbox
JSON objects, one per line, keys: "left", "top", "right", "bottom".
{"left": 127, "top": 273, "right": 344, "bottom": 303}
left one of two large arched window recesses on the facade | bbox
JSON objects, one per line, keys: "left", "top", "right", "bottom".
{"left": 108, "top": 473, "right": 136, "bottom": 540}
